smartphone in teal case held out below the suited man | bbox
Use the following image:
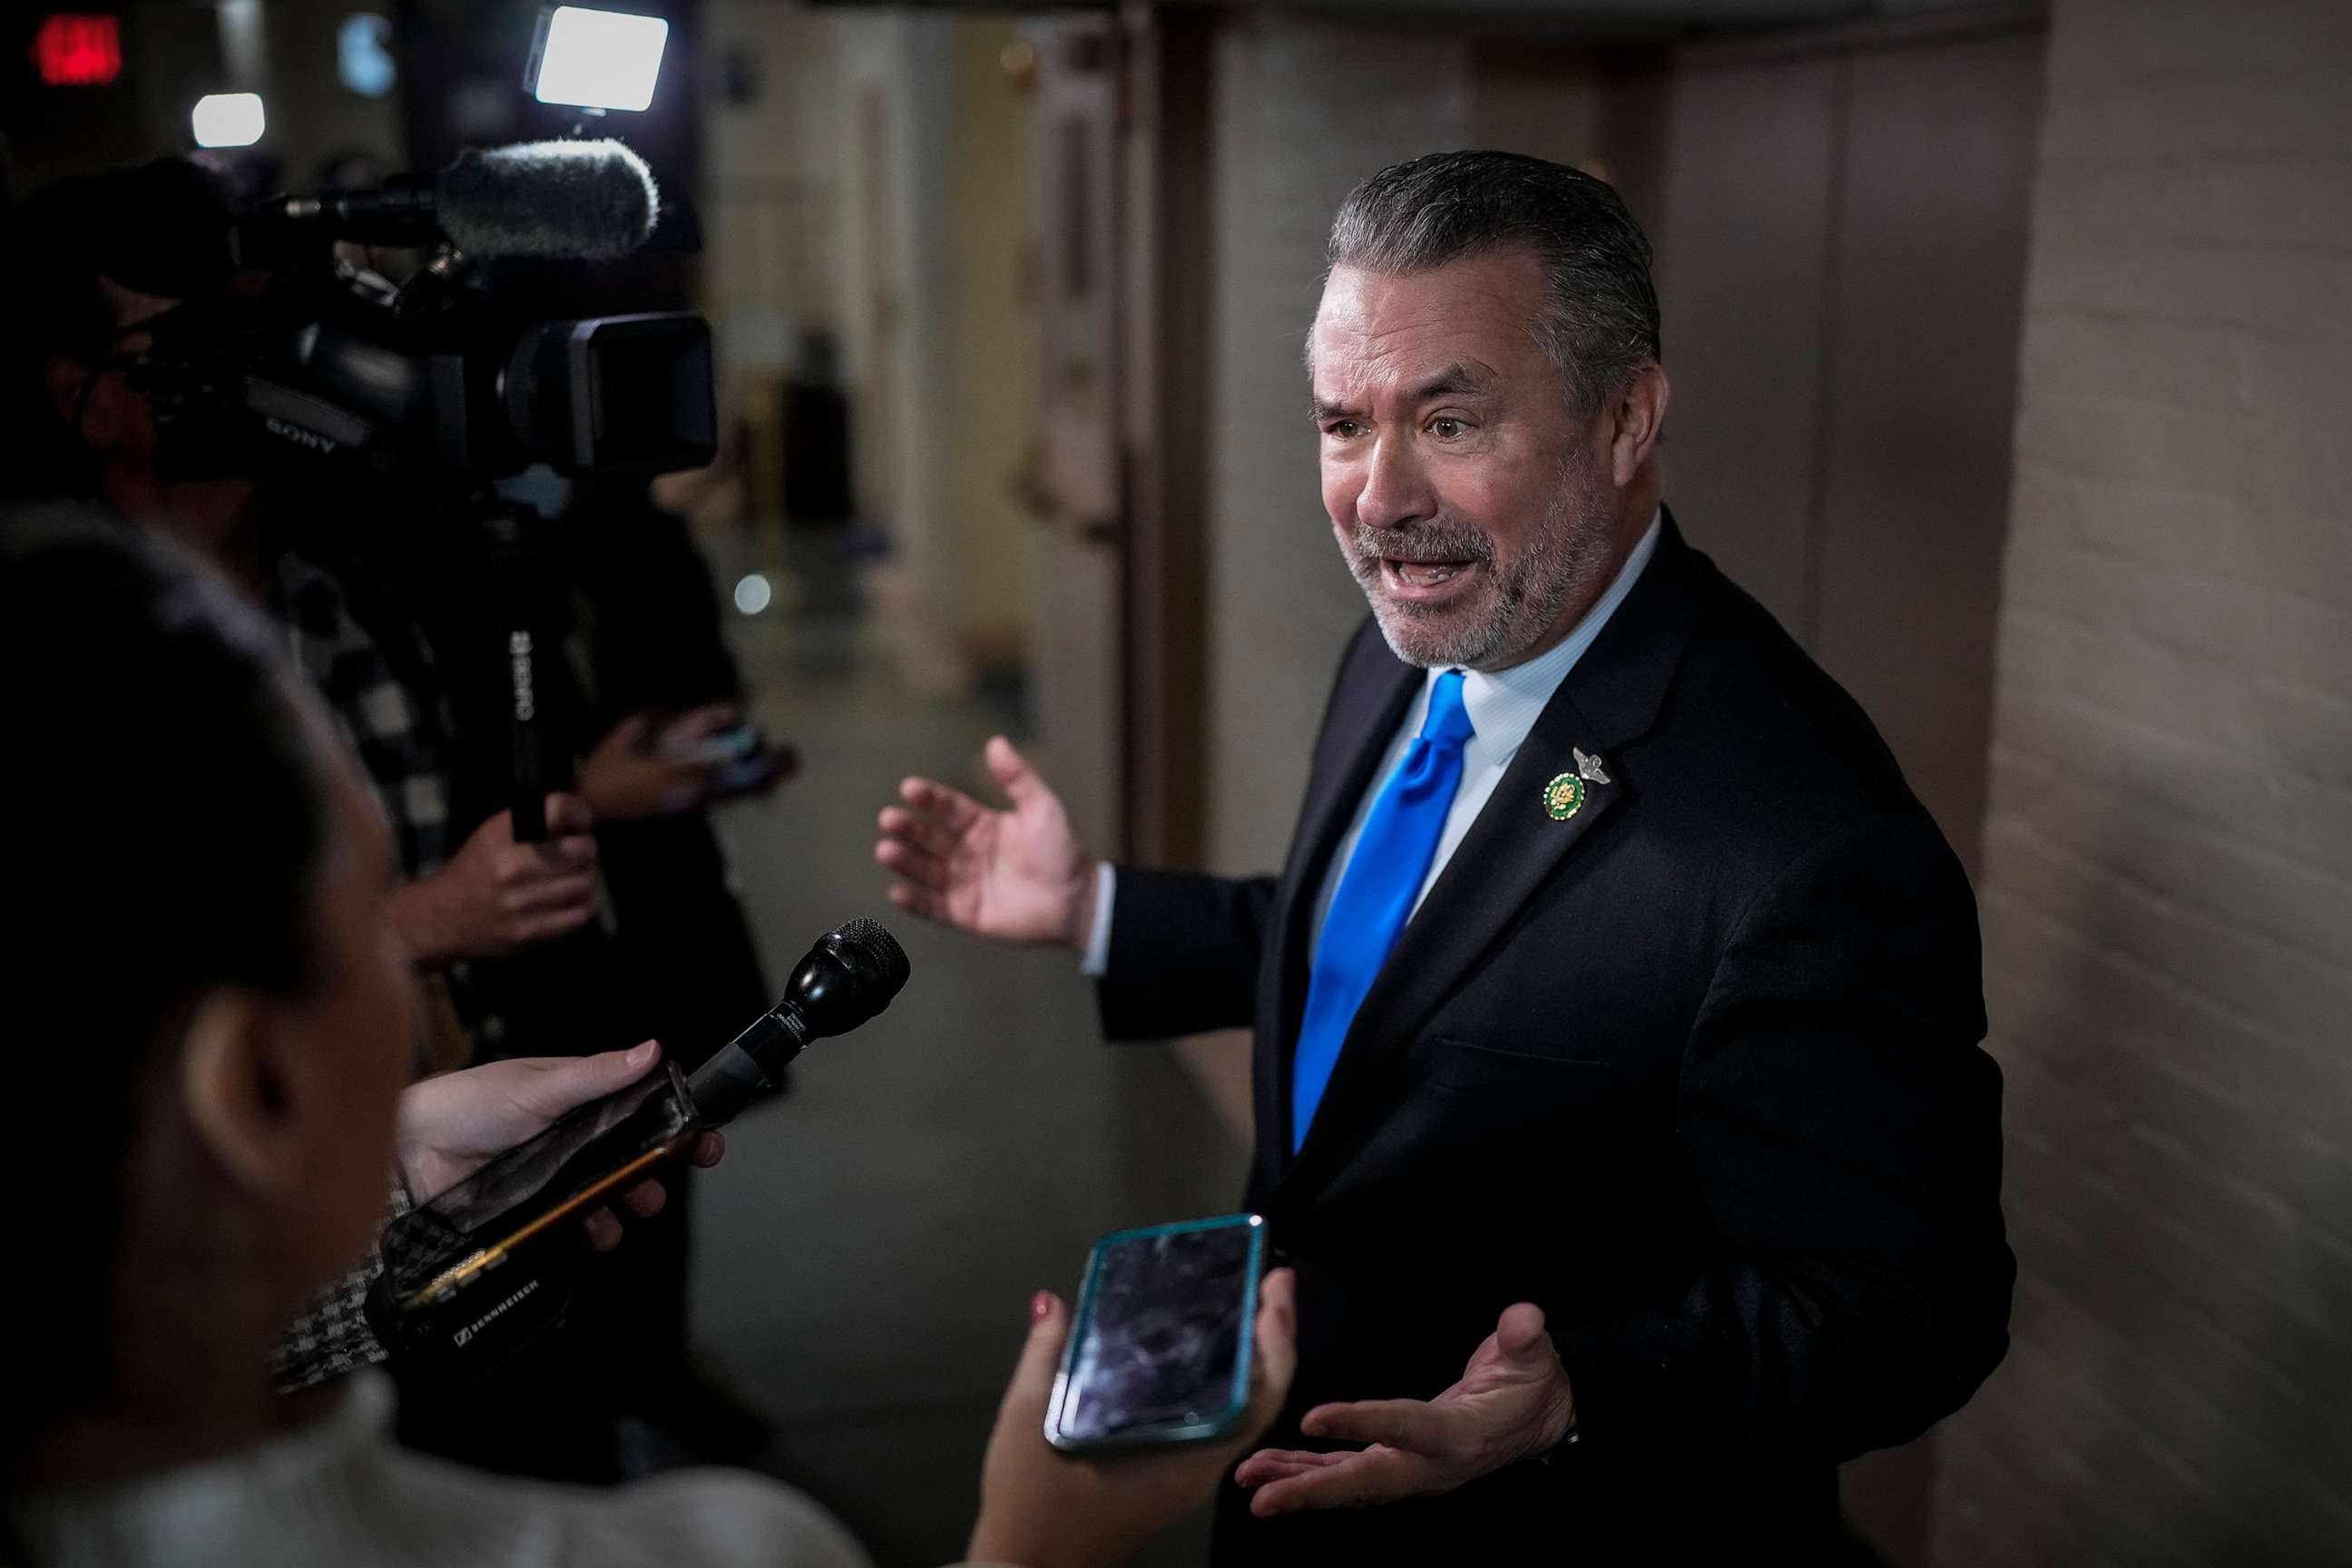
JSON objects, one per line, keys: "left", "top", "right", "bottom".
{"left": 1044, "top": 1213, "right": 1265, "bottom": 1453}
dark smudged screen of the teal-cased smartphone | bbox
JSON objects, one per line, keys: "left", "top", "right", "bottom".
{"left": 1061, "top": 1225, "right": 1251, "bottom": 1439}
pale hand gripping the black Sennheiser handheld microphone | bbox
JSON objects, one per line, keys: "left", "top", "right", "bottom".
{"left": 393, "top": 1042, "right": 727, "bottom": 1250}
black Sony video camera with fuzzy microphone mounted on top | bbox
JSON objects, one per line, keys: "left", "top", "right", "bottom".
{"left": 130, "top": 141, "right": 718, "bottom": 491}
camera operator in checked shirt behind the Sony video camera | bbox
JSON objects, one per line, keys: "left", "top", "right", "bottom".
{"left": 0, "top": 158, "right": 597, "bottom": 1005}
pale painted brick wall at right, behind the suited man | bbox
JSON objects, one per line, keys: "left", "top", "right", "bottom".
{"left": 1934, "top": 0, "right": 2352, "bottom": 1568}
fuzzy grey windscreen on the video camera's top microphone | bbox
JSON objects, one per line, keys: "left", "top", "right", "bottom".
{"left": 433, "top": 139, "right": 661, "bottom": 261}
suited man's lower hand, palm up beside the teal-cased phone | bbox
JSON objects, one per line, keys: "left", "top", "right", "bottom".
{"left": 1232, "top": 1302, "right": 1576, "bottom": 1519}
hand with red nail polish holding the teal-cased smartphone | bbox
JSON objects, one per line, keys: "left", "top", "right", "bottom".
{"left": 965, "top": 1269, "right": 1296, "bottom": 1568}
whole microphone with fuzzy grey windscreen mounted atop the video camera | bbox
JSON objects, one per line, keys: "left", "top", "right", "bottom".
{"left": 268, "top": 139, "right": 661, "bottom": 261}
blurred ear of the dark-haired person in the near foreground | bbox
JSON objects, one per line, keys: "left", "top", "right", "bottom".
{"left": 179, "top": 985, "right": 309, "bottom": 1199}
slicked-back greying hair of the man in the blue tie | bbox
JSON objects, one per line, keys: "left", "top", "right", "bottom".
{"left": 1324, "top": 152, "right": 1658, "bottom": 411}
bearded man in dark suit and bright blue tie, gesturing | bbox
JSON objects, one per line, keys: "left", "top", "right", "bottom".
{"left": 875, "top": 152, "right": 2014, "bottom": 1561}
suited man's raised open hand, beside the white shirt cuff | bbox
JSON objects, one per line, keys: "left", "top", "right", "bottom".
{"left": 875, "top": 736, "right": 1093, "bottom": 950}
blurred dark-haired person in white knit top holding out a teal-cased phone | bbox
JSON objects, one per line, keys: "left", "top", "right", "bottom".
{"left": 0, "top": 517, "right": 1291, "bottom": 1568}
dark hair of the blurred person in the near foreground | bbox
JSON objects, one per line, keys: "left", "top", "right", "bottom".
{"left": 0, "top": 505, "right": 327, "bottom": 1446}
